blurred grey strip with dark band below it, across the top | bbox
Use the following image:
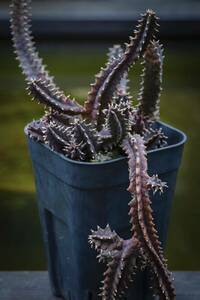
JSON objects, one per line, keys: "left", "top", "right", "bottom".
{"left": 0, "top": 0, "right": 200, "bottom": 39}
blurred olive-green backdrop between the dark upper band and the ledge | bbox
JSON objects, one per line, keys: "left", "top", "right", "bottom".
{"left": 0, "top": 41, "right": 200, "bottom": 270}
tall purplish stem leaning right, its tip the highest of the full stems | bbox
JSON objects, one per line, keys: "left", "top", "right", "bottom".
{"left": 95, "top": 10, "right": 157, "bottom": 129}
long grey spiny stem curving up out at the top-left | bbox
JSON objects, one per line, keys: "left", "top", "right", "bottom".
{"left": 11, "top": 0, "right": 83, "bottom": 113}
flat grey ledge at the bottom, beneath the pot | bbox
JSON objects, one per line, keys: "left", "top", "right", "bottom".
{"left": 0, "top": 272, "right": 200, "bottom": 300}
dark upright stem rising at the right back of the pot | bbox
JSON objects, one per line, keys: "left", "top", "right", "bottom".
{"left": 138, "top": 41, "right": 163, "bottom": 120}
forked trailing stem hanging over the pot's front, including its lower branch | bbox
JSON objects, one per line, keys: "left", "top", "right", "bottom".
{"left": 89, "top": 135, "right": 175, "bottom": 300}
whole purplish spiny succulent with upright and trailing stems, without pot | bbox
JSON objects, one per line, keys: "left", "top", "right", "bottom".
{"left": 11, "top": 0, "right": 175, "bottom": 300}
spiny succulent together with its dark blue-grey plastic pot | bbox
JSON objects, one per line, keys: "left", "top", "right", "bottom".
{"left": 11, "top": 0, "right": 186, "bottom": 300}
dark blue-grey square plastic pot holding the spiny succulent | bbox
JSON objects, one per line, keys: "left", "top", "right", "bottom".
{"left": 28, "top": 123, "right": 186, "bottom": 300}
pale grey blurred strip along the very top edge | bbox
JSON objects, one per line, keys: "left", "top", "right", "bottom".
{"left": 0, "top": 0, "right": 200, "bottom": 20}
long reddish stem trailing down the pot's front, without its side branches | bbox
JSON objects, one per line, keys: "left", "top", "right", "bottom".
{"left": 123, "top": 135, "right": 175, "bottom": 300}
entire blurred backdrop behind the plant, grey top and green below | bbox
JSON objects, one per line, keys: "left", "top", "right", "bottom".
{"left": 0, "top": 0, "right": 200, "bottom": 270}
